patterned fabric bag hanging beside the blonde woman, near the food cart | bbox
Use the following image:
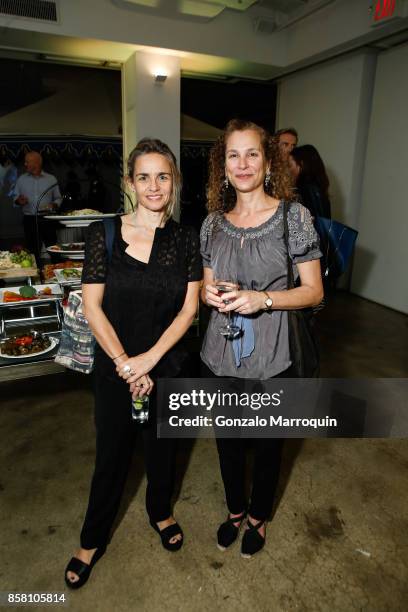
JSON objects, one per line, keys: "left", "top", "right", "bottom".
{"left": 55, "top": 291, "right": 95, "bottom": 374}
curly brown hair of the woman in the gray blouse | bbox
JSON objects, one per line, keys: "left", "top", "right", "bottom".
{"left": 207, "top": 119, "right": 294, "bottom": 212}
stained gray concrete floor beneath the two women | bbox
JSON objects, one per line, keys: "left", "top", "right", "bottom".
{"left": 0, "top": 294, "right": 408, "bottom": 612}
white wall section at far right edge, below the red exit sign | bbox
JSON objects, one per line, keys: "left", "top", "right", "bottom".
{"left": 352, "top": 45, "right": 408, "bottom": 313}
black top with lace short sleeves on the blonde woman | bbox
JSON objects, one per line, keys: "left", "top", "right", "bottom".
{"left": 82, "top": 217, "right": 202, "bottom": 380}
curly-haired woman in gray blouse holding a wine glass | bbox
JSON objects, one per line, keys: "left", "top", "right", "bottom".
{"left": 201, "top": 119, "right": 323, "bottom": 557}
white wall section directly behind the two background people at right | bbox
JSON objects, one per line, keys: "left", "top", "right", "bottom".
{"left": 277, "top": 53, "right": 376, "bottom": 227}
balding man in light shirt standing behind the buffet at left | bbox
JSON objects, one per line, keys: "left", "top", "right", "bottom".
{"left": 14, "top": 151, "right": 62, "bottom": 264}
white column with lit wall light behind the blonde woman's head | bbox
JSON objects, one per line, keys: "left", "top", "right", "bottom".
{"left": 122, "top": 51, "right": 180, "bottom": 217}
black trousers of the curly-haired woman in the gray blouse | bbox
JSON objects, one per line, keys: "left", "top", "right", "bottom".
{"left": 201, "top": 364, "right": 293, "bottom": 521}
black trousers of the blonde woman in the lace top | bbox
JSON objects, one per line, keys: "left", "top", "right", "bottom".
{"left": 81, "top": 372, "right": 176, "bottom": 549}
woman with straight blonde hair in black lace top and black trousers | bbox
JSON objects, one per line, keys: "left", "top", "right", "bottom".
{"left": 65, "top": 138, "right": 202, "bottom": 589}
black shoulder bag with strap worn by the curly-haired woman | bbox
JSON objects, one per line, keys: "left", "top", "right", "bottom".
{"left": 283, "top": 202, "right": 320, "bottom": 378}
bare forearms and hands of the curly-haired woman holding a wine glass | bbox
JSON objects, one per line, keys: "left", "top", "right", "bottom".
{"left": 201, "top": 259, "right": 323, "bottom": 314}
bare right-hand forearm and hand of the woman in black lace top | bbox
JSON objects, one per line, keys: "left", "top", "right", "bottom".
{"left": 116, "top": 281, "right": 200, "bottom": 383}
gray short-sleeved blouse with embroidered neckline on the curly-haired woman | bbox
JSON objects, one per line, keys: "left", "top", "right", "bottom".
{"left": 200, "top": 202, "right": 322, "bottom": 380}
